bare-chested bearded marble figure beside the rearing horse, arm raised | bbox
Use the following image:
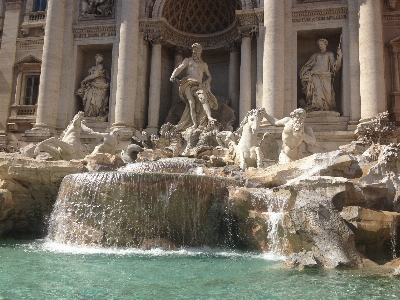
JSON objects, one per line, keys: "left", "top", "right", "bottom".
{"left": 265, "top": 108, "right": 317, "bottom": 164}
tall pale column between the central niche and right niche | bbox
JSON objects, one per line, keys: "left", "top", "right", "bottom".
{"left": 262, "top": 0, "right": 285, "bottom": 118}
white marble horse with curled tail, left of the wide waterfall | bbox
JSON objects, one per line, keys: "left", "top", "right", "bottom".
{"left": 34, "top": 111, "right": 99, "bottom": 160}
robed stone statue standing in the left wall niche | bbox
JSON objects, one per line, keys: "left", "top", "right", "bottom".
{"left": 76, "top": 54, "right": 110, "bottom": 121}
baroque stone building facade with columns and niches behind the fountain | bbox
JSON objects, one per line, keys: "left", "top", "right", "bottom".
{"left": 0, "top": 0, "right": 400, "bottom": 147}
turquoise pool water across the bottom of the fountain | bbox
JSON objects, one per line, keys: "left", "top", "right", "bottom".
{"left": 0, "top": 240, "right": 400, "bottom": 299}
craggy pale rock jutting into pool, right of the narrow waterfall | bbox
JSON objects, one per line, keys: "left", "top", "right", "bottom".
{"left": 282, "top": 177, "right": 362, "bottom": 267}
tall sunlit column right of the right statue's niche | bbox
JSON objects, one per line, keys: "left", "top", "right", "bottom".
{"left": 358, "top": 0, "right": 386, "bottom": 119}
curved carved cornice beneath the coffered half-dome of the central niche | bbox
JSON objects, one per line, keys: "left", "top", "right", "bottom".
{"left": 139, "top": 18, "right": 240, "bottom": 49}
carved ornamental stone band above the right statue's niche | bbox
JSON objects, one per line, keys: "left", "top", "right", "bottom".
{"left": 292, "top": 6, "right": 348, "bottom": 23}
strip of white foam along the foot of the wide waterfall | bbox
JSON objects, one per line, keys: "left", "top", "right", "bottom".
{"left": 28, "top": 239, "right": 286, "bottom": 261}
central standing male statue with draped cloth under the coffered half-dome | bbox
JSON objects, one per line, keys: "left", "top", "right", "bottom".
{"left": 170, "top": 43, "right": 218, "bottom": 131}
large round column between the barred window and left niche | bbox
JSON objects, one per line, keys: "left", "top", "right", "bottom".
{"left": 33, "top": 0, "right": 67, "bottom": 131}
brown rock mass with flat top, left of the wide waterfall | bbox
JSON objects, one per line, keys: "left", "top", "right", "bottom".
{"left": 0, "top": 153, "right": 86, "bottom": 239}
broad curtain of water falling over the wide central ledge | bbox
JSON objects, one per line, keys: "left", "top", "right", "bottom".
{"left": 49, "top": 172, "right": 241, "bottom": 247}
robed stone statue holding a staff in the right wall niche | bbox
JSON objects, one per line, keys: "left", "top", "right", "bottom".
{"left": 300, "top": 39, "right": 342, "bottom": 111}
